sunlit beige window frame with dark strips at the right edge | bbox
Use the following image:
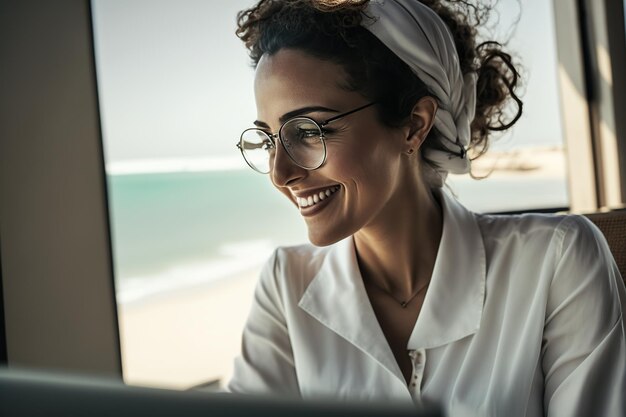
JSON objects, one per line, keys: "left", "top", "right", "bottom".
{"left": 552, "top": 0, "right": 626, "bottom": 213}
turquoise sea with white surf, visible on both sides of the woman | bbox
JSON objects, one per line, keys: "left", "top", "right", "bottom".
{"left": 107, "top": 170, "right": 567, "bottom": 302}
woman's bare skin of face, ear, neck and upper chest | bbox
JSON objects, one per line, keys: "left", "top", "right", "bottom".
{"left": 254, "top": 49, "right": 442, "bottom": 382}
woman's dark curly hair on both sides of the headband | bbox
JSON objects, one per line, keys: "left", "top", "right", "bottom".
{"left": 236, "top": 0, "right": 522, "bottom": 182}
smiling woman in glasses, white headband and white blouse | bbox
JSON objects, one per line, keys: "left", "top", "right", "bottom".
{"left": 229, "top": 0, "right": 626, "bottom": 416}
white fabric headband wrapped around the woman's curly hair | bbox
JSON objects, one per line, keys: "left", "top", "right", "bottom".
{"left": 362, "top": 0, "right": 477, "bottom": 185}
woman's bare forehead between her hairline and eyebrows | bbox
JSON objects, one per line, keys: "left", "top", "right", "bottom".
{"left": 254, "top": 49, "right": 360, "bottom": 123}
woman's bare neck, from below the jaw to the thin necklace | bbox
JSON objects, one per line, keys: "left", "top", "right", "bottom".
{"left": 354, "top": 176, "right": 443, "bottom": 300}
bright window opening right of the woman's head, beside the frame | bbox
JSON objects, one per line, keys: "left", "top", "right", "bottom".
{"left": 448, "top": 0, "right": 569, "bottom": 212}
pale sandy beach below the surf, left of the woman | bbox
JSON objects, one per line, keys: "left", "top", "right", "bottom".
{"left": 118, "top": 271, "right": 258, "bottom": 389}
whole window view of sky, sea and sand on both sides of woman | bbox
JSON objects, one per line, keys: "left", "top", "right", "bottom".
{"left": 92, "top": 0, "right": 568, "bottom": 388}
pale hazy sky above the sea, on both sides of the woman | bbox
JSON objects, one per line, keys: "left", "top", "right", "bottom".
{"left": 92, "top": 0, "right": 562, "bottom": 168}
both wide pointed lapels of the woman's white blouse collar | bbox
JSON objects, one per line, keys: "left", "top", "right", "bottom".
{"left": 298, "top": 192, "right": 486, "bottom": 377}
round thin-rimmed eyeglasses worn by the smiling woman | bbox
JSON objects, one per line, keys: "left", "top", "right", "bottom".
{"left": 237, "top": 102, "right": 375, "bottom": 174}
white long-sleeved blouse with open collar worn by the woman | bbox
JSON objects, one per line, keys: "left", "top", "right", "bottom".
{"left": 228, "top": 193, "right": 626, "bottom": 416}
